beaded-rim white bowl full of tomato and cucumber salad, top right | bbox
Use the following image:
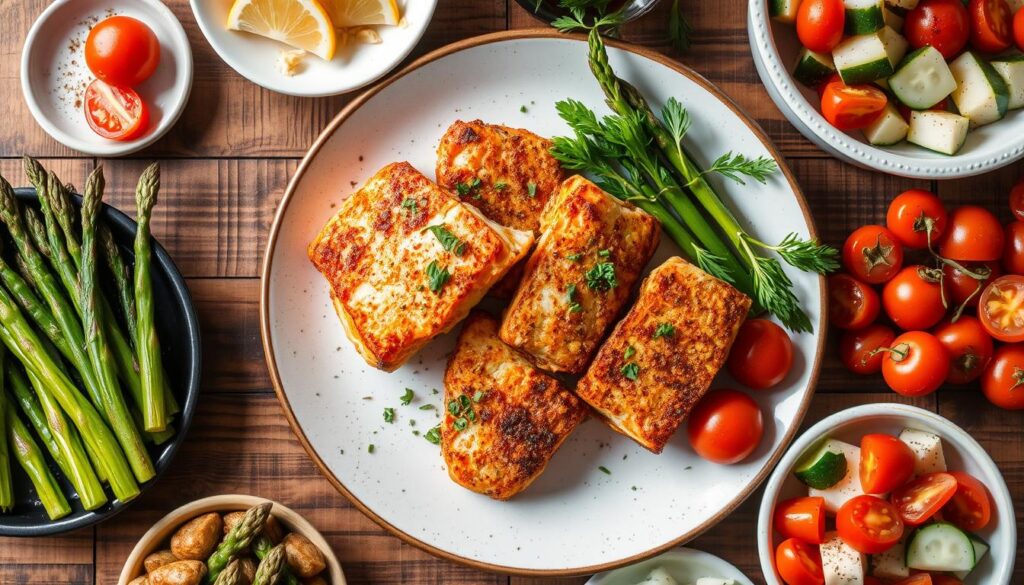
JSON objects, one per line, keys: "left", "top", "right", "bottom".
{"left": 748, "top": 0, "right": 1024, "bottom": 179}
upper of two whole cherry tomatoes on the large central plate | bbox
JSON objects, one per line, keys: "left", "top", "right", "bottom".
{"left": 727, "top": 319, "right": 793, "bottom": 390}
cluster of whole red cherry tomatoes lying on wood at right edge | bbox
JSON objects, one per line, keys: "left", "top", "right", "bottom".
{"left": 828, "top": 184, "right": 1024, "bottom": 409}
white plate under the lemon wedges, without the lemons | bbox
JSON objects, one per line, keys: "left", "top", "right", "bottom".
{"left": 190, "top": 0, "right": 437, "bottom": 97}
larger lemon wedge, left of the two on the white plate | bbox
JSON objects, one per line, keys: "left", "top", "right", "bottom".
{"left": 227, "top": 0, "right": 335, "bottom": 60}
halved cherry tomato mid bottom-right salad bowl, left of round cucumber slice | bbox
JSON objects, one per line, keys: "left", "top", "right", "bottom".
{"left": 836, "top": 493, "right": 903, "bottom": 554}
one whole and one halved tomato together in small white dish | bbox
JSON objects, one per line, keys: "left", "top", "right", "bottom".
{"left": 82, "top": 15, "right": 160, "bottom": 140}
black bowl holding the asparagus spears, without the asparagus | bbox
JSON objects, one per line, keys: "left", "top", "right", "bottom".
{"left": 0, "top": 187, "right": 203, "bottom": 536}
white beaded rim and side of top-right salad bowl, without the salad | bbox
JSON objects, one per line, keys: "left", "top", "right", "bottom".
{"left": 746, "top": 0, "right": 1024, "bottom": 179}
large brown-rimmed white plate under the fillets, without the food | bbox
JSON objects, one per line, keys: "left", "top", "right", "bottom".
{"left": 261, "top": 31, "right": 824, "bottom": 575}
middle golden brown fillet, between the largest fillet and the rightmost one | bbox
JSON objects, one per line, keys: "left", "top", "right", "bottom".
{"left": 501, "top": 175, "right": 660, "bottom": 374}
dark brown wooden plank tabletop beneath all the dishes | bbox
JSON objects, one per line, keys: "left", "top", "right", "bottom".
{"left": 0, "top": 0, "right": 1024, "bottom": 585}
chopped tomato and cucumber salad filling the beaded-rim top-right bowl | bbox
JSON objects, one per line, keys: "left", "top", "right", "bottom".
{"left": 768, "top": 0, "right": 1024, "bottom": 155}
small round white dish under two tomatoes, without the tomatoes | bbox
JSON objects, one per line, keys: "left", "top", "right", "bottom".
{"left": 22, "top": 0, "right": 193, "bottom": 157}
